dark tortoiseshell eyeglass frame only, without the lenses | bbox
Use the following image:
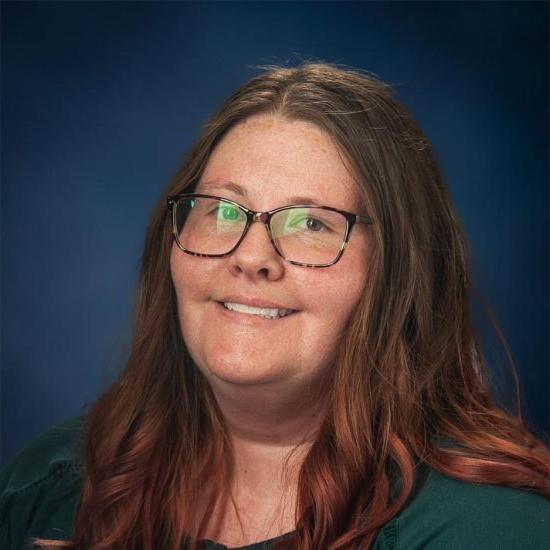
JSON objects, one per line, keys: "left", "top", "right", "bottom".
{"left": 166, "top": 193, "right": 374, "bottom": 267}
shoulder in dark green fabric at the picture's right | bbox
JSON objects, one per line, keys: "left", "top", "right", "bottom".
{"left": 383, "top": 469, "right": 550, "bottom": 550}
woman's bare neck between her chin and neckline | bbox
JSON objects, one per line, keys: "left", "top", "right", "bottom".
{"left": 202, "top": 379, "right": 326, "bottom": 546}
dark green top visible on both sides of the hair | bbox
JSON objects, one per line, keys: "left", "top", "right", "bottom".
{"left": 0, "top": 417, "right": 550, "bottom": 550}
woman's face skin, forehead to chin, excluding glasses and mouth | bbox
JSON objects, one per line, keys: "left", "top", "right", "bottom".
{"left": 171, "top": 115, "right": 374, "bottom": 396}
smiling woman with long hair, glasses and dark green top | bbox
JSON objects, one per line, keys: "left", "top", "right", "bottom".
{"left": 0, "top": 64, "right": 550, "bottom": 550}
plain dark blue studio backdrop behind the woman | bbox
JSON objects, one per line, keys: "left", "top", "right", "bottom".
{"left": 1, "top": 2, "right": 548, "bottom": 462}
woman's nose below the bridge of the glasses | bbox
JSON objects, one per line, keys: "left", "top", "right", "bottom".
{"left": 228, "top": 220, "right": 285, "bottom": 281}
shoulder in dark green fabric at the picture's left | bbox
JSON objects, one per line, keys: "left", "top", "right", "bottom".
{"left": 0, "top": 416, "right": 84, "bottom": 549}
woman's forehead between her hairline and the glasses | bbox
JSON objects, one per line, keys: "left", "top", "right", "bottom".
{"left": 196, "top": 115, "right": 359, "bottom": 210}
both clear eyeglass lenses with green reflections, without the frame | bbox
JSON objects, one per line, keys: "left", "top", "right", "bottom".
{"left": 175, "top": 197, "right": 347, "bottom": 264}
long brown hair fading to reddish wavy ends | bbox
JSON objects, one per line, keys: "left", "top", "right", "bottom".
{"left": 33, "top": 63, "right": 550, "bottom": 550}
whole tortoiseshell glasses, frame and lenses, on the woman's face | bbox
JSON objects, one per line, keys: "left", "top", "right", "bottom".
{"left": 167, "top": 193, "right": 373, "bottom": 267}
